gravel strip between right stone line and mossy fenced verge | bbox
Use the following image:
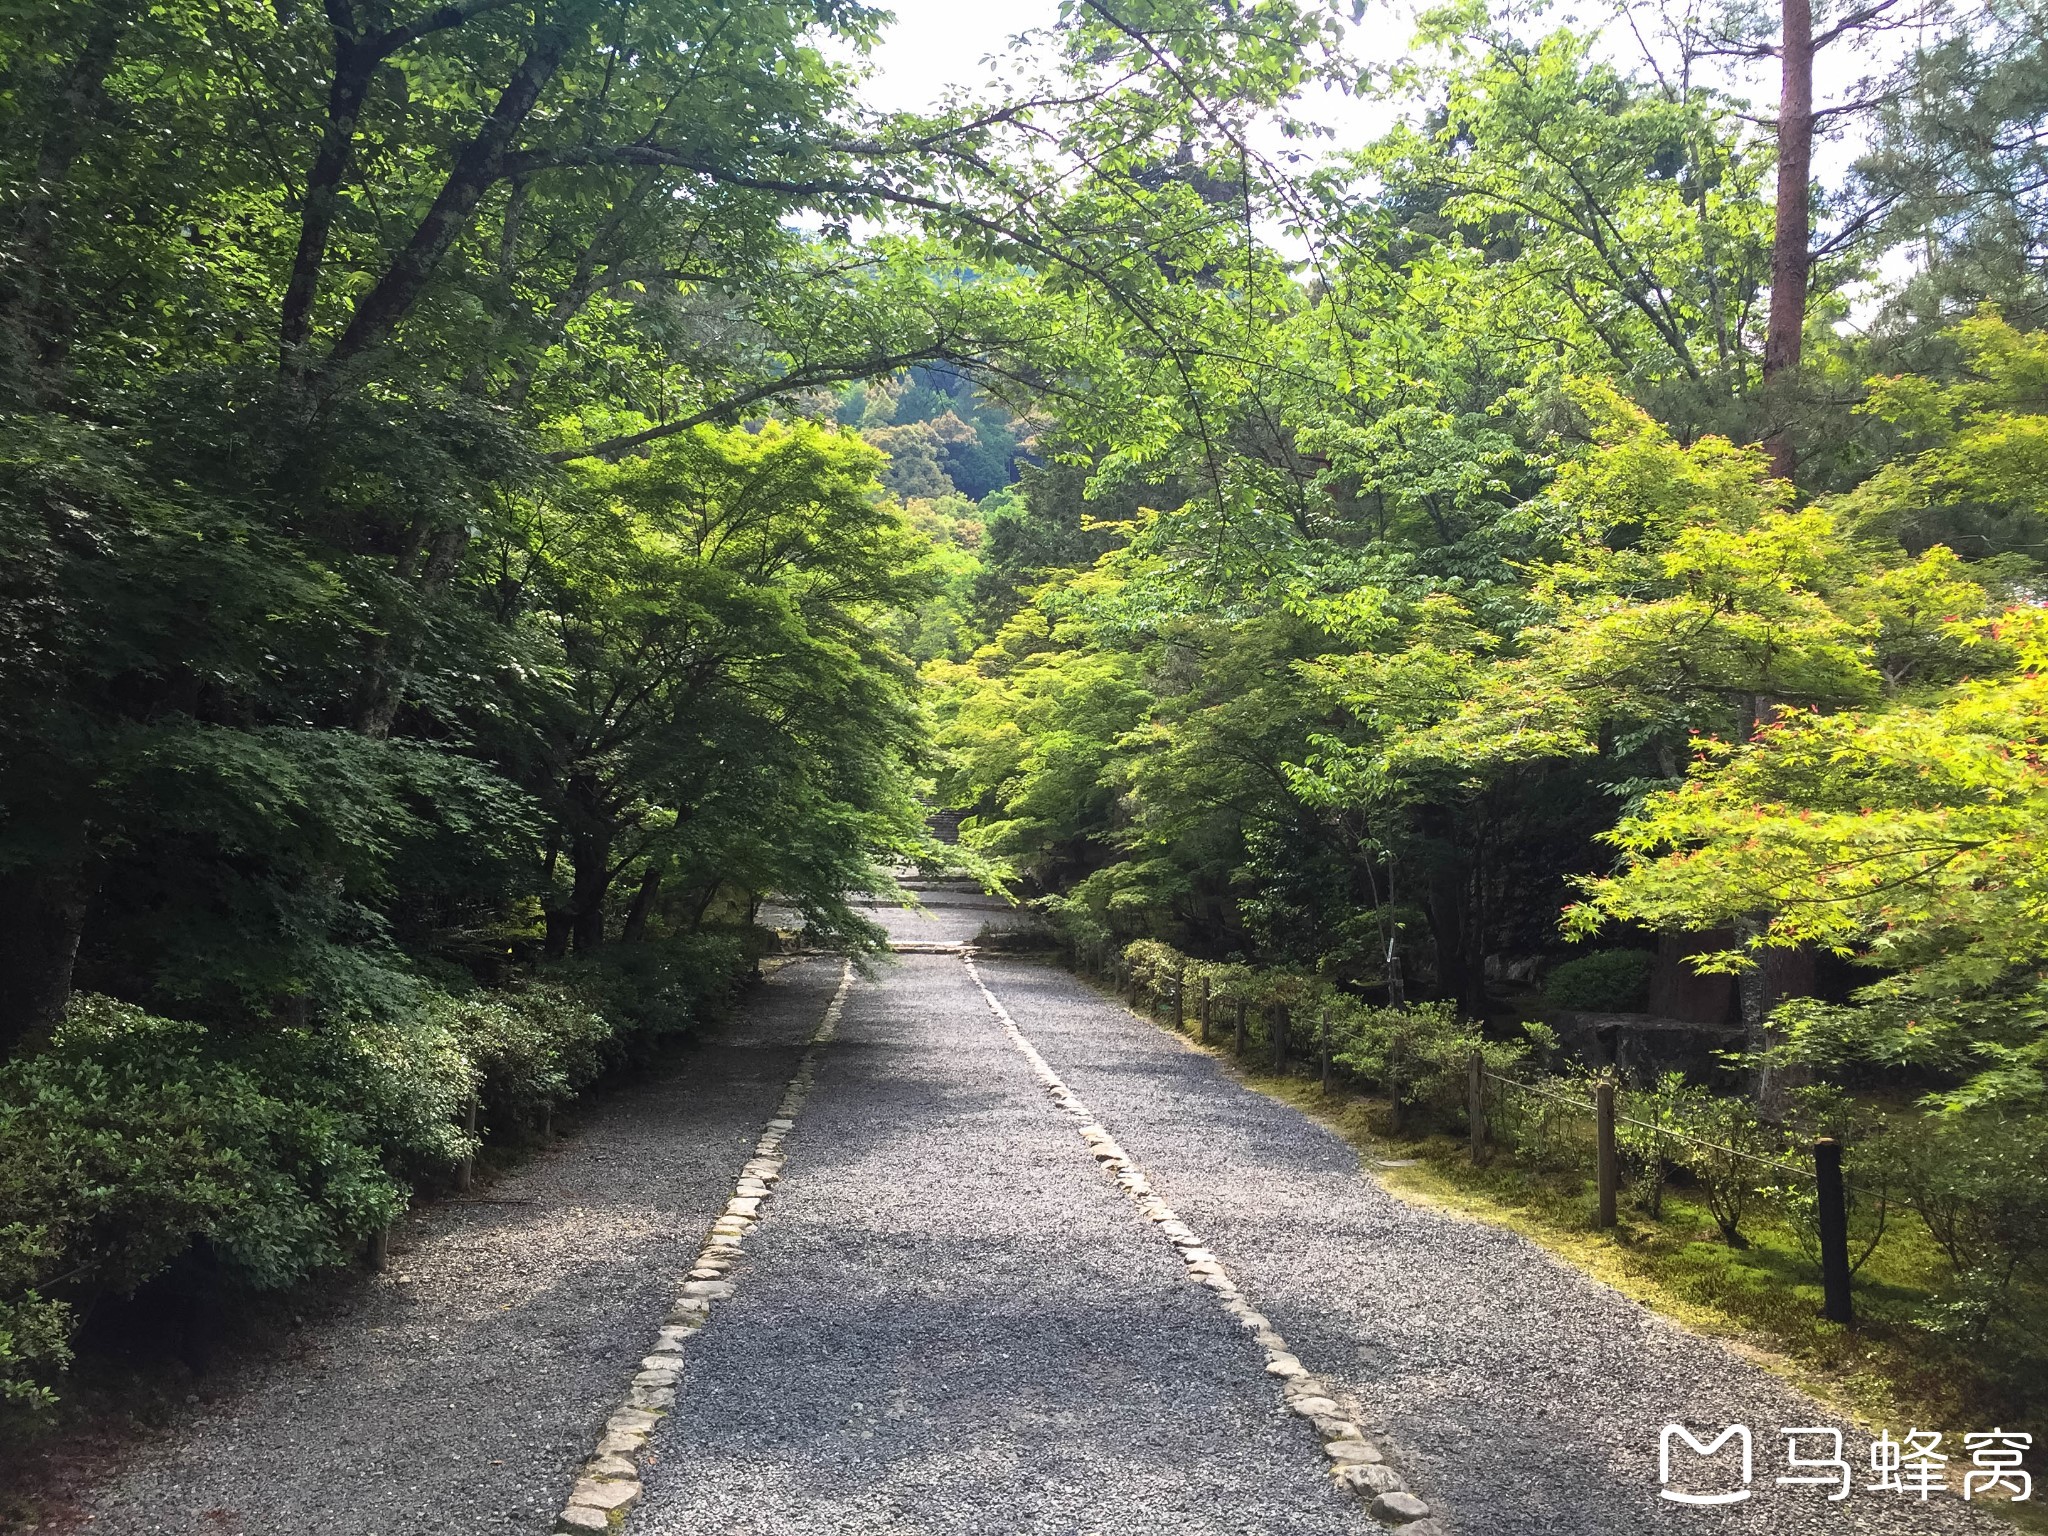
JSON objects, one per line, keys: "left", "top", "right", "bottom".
{"left": 979, "top": 958, "right": 2038, "bottom": 1536}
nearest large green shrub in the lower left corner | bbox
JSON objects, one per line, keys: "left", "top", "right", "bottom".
{"left": 0, "top": 997, "right": 419, "bottom": 1405}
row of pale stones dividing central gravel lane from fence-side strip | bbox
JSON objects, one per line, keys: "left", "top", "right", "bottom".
{"left": 954, "top": 946, "right": 1444, "bottom": 1536}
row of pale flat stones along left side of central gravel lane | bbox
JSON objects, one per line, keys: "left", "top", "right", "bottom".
{"left": 555, "top": 961, "right": 854, "bottom": 1536}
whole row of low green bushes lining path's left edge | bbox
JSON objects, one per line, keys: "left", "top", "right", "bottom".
{"left": 0, "top": 932, "right": 754, "bottom": 1411}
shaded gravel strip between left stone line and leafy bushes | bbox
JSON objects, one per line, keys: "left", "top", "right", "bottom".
{"left": 74, "top": 961, "right": 840, "bottom": 1536}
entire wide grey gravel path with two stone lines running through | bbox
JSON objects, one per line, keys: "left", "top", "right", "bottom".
{"left": 75, "top": 901, "right": 2007, "bottom": 1536}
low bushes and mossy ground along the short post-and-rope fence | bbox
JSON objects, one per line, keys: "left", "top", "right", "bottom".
{"left": 1120, "top": 940, "right": 2048, "bottom": 1415}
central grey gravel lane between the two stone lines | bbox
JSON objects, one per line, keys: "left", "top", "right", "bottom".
{"left": 633, "top": 956, "right": 1372, "bottom": 1536}
